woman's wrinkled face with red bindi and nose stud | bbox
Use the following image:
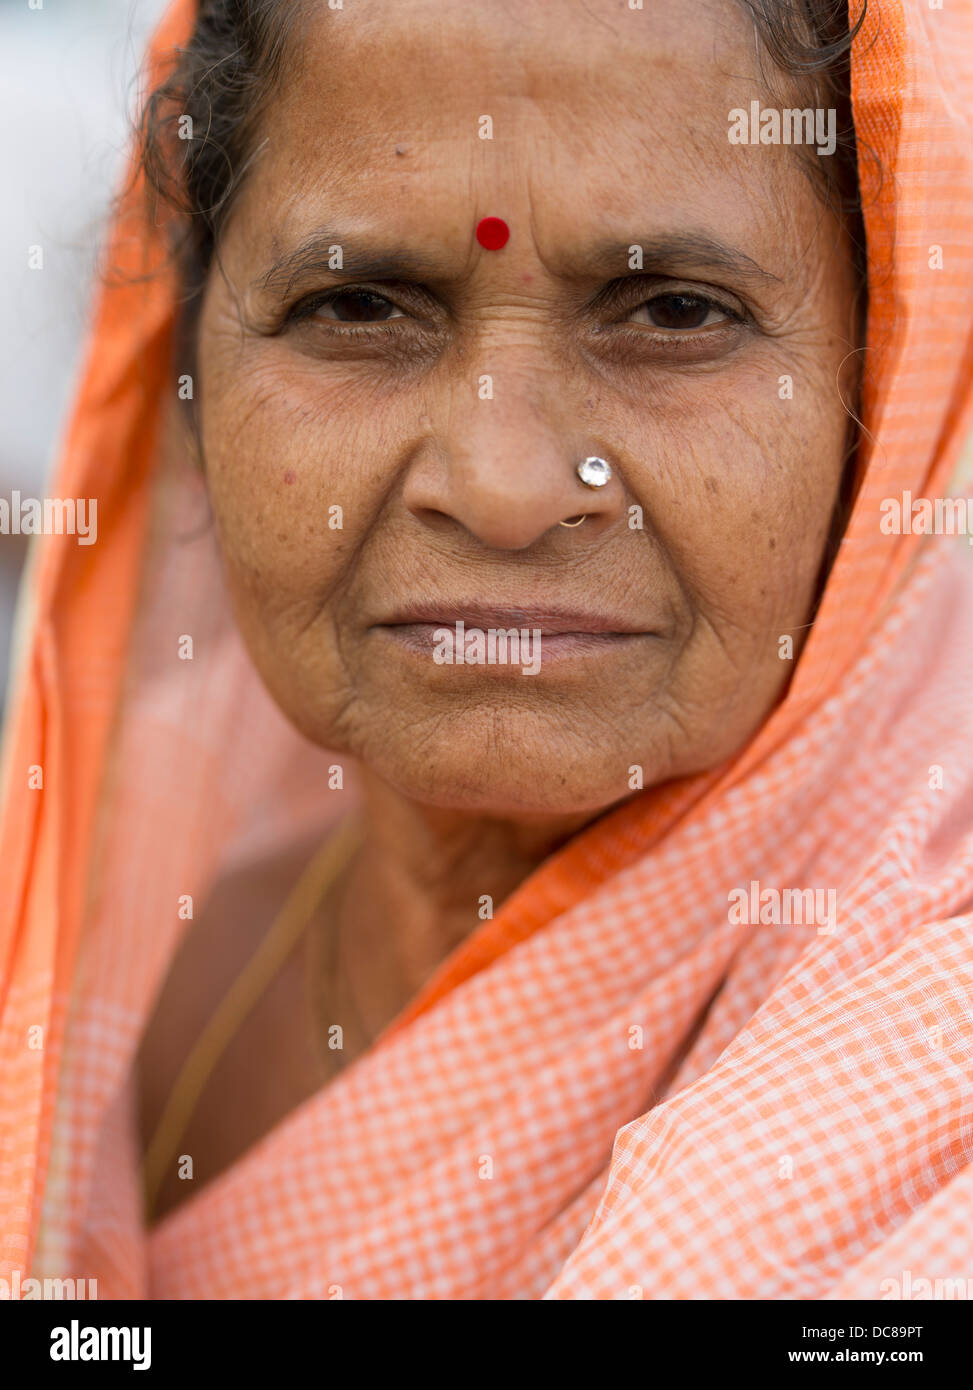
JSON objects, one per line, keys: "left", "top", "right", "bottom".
{"left": 199, "top": 0, "right": 855, "bottom": 816}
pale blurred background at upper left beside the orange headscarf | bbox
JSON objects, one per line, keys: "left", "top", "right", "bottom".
{"left": 0, "top": 0, "right": 167, "bottom": 710}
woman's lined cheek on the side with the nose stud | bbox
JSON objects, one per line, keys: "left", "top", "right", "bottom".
{"left": 632, "top": 353, "right": 847, "bottom": 627}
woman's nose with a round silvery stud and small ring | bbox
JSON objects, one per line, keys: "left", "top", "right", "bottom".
{"left": 403, "top": 373, "right": 626, "bottom": 550}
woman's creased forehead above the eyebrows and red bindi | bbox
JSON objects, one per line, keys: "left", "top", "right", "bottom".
{"left": 239, "top": 0, "right": 806, "bottom": 276}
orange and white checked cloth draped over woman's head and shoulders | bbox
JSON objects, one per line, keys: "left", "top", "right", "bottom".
{"left": 0, "top": 0, "right": 973, "bottom": 1298}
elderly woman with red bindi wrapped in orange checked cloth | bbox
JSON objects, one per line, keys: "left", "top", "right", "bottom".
{"left": 0, "top": 0, "right": 973, "bottom": 1298}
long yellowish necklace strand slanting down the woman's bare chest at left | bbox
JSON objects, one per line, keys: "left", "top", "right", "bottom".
{"left": 142, "top": 817, "right": 361, "bottom": 1219}
